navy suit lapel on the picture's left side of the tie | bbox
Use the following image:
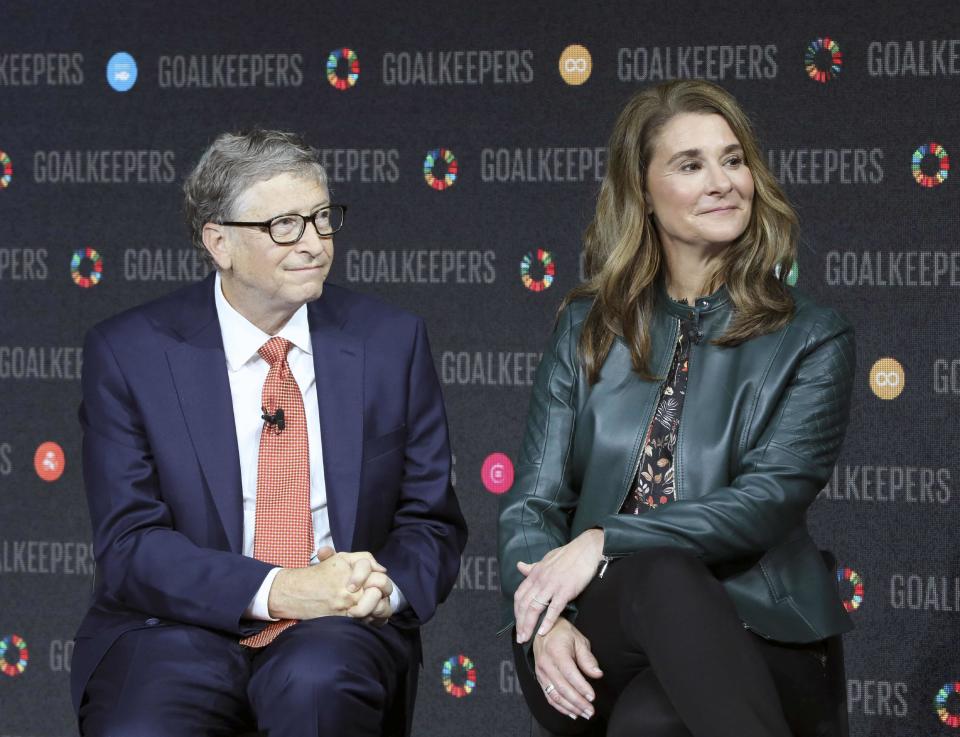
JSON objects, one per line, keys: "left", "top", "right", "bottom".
{"left": 167, "top": 275, "right": 243, "bottom": 553}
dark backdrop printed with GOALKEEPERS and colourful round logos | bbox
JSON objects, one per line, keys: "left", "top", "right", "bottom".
{"left": 0, "top": 0, "right": 960, "bottom": 737}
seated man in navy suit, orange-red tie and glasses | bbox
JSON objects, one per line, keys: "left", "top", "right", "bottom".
{"left": 72, "top": 130, "right": 466, "bottom": 737}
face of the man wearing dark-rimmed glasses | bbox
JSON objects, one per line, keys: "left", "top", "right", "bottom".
{"left": 208, "top": 174, "right": 333, "bottom": 333}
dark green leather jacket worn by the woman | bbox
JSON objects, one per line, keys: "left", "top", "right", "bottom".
{"left": 499, "top": 289, "right": 855, "bottom": 642}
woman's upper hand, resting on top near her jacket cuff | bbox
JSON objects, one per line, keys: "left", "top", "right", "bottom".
{"left": 513, "top": 529, "right": 603, "bottom": 643}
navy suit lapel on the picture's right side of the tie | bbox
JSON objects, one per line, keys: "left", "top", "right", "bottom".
{"left": 308, "top": 289, "right": 364, "bottom": 551}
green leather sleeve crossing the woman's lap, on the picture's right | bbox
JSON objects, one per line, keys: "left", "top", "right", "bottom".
{"left": 597, "top": 313, "right": 855, "bottom": 564}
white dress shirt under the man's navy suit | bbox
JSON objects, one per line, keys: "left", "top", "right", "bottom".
{"left": 214, "top": 273, "right": 406, "bottom": 620}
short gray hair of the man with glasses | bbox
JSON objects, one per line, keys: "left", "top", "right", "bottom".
{"left": 183, "top": 128, "right": 327, "bottom": 263}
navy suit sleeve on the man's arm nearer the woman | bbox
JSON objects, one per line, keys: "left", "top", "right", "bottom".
{"left": 373, "top": 319, "right": 467, "bottom": 624}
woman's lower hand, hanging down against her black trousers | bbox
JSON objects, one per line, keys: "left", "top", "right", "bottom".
{"left": 533, "top": 619, "right": 603, "bottom": 719}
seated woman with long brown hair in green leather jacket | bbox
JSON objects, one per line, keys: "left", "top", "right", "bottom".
{"left": 500, "top": 81, "right": 854, "bottom": 737}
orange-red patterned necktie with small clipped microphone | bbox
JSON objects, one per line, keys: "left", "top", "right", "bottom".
{"left": 240, "top": 338, "right": 314, "bottom": 647}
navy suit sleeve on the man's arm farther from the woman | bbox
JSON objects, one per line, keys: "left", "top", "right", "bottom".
{"left": 80, "top": 328, "right": 270, "bottom": 635}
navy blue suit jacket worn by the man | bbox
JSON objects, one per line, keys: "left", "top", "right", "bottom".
{"left": 71, "top": 275, "right": 466, "bottom": 708}
